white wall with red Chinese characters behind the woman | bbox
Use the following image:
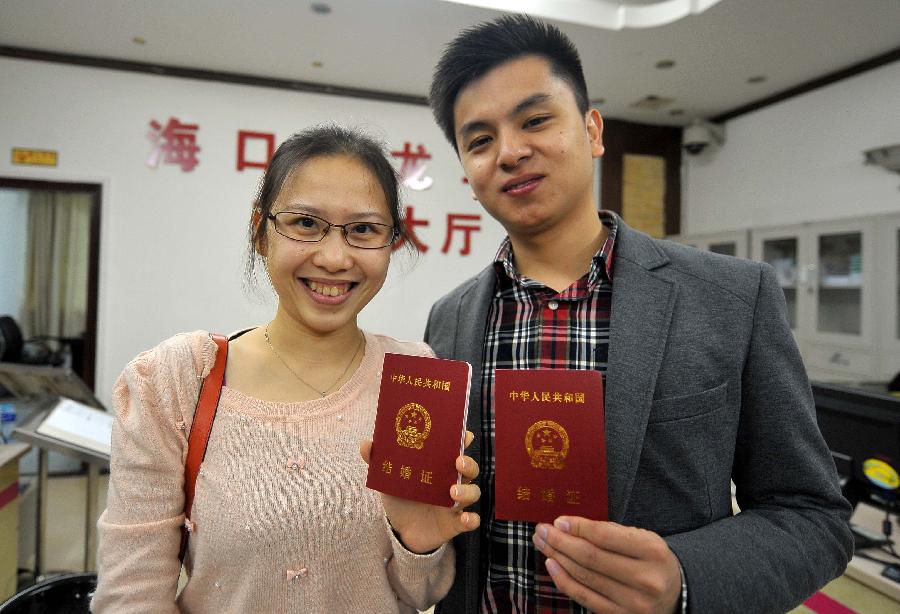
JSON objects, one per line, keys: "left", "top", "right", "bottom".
{"left": 0, "top": 58, "right": 504, "bottom": 401}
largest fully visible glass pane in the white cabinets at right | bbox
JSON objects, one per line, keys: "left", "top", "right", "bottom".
{"left": 816, "top": 232, "right": 864, "bottom": 335}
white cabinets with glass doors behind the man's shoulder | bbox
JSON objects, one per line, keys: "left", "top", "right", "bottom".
{"left": 669, "top": 214, "right": 900, "bottom": 381}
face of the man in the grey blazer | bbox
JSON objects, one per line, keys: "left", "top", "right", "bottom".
{"left": 453, "top": 56, "right": 603, "bottom": 239}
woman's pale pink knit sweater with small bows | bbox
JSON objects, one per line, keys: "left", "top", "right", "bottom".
{"left": 92, "top": 331, "right": 454, "bottom": 614}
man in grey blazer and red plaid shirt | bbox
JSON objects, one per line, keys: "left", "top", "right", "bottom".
{"left": 425, "top": 17, "right": 852, "bottom": 614}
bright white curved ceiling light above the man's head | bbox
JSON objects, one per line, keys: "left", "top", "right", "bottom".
{"left": 444, "top": 0, "right": 721, "bottom": 30}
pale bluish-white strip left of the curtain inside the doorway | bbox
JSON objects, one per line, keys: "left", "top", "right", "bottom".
{"left": 0, "top": 189, "right": 28, "bottom": 322}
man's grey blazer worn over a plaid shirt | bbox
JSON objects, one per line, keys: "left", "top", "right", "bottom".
{"left": 425, "top": 220, "right": 853, "bottom": 614}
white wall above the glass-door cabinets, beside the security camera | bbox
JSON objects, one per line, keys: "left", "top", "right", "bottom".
{"left": 682, "top": 62, "right": 900, "bottom": 235}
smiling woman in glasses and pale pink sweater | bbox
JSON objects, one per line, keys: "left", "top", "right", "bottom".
{"left": 92, "top": 125, "right": 479, "bottom": 614}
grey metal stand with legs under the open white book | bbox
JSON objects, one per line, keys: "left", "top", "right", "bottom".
{"left": 13, "top": 411, "right": 109, "bottom": 577}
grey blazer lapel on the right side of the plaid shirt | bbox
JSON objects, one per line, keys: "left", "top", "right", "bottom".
{"left": 605, "top": 224, "right": 676, "bottom": 522}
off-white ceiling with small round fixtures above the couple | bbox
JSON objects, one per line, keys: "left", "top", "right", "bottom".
{"left": 0, "top": 0, "right": 900, "bottom": 125}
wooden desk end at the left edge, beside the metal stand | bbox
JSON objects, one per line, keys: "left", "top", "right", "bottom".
{"left": 0, "top": 442, "right": 31, "bottom": 601}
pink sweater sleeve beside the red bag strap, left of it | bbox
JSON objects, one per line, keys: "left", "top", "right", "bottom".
{"left": 91, "top": 333, "right": 215, "bottom": 614}
